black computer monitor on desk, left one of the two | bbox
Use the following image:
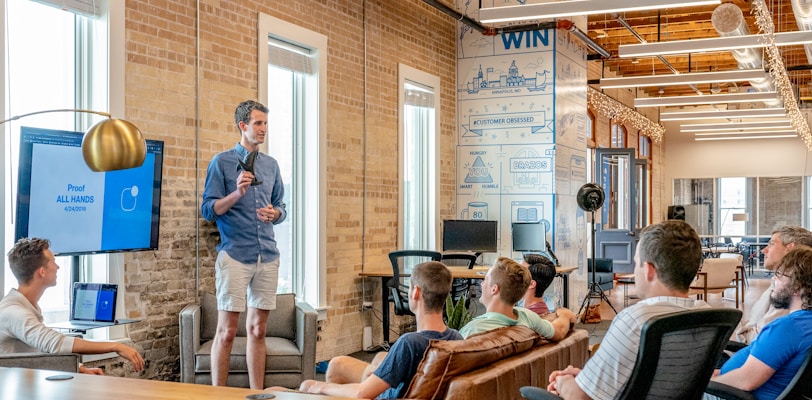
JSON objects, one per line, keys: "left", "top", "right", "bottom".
{"left": 443, "top": 219, "right": 497, "bottom": 253}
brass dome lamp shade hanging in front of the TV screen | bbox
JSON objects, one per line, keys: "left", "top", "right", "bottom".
{"left": 82, "top": 118, "right": 147, "bottom": 172}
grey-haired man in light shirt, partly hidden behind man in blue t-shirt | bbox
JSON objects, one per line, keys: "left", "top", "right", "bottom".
{"left": 733, "top": 226, "right": 812, "bottom": 344}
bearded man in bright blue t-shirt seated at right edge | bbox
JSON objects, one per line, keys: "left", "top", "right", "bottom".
{"left": 712, "top": 246, "right": 812, "bottom": 400}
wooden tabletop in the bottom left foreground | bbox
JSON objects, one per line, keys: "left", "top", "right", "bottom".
{"left": 0, "top": 367, "right": 356, "bottom": 400}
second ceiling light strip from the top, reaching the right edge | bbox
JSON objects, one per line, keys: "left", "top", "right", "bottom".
{"left": 617, "top": 31, "right": 812, "bottom": 58}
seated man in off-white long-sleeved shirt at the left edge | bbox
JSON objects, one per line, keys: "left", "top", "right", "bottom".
{"left": 0, "top": 238, "right": 144, "bottom": 375}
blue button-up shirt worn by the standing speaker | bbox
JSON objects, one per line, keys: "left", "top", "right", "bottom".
{"left": 200, "top": 143, "right": 288, "bottom": 264}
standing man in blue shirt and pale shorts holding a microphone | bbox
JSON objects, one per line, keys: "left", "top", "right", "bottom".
{"left": 201, "top": 100, "right": 287, "bottom": 389}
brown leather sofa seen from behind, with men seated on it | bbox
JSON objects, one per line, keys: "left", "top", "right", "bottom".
{"left": 406, "top": 326, "right": 589, "bottom": 400}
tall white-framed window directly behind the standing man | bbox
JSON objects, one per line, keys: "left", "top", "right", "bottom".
{"left": 259, "top": 14, "right": 327, "bottom": 312}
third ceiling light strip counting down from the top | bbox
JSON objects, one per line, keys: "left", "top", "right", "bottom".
{"left": 600, "top": 69, "right": 767, "bottom": 89}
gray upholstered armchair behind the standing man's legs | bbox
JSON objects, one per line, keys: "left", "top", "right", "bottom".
{"left": 180, "top": 293, "right": 317, "bottom": 388}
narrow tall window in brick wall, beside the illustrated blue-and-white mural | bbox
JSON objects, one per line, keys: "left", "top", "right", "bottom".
{"left": 398, "top": 64, "right": 440, "bottom": 250}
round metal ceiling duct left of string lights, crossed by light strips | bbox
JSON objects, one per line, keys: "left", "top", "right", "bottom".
{"left": 711, "top": 3, "right": 775, "bottom": 96}
